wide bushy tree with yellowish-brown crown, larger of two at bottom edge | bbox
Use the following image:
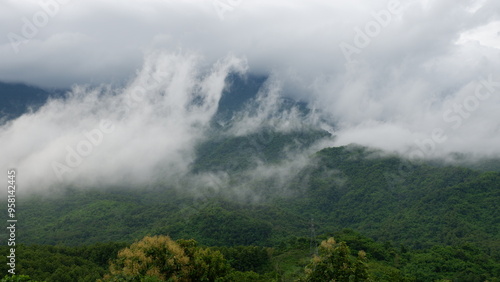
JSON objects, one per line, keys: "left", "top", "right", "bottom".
{"left": 104, "top": 236, "right": 234, "bottom": 281}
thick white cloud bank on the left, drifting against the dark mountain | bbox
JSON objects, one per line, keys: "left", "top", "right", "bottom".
{"left": 0, "top": 53, "right": 246, "bottom": 192}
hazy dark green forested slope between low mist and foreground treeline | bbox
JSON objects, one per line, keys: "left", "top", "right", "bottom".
{"left": 14, "top": 141, "right": 500, "bottom": 251}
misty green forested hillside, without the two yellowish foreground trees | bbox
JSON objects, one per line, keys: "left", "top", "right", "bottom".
{"left": 3, "top": 131, "right": 500, "bottom": 281}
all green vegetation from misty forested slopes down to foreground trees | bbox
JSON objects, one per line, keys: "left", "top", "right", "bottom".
{"left": 0, "top": 131, "right": 500, "bottom": 281}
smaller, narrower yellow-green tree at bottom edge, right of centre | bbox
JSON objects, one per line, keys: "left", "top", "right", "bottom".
{"left": 304, "top": 238, "right": 370, "bottom": 282}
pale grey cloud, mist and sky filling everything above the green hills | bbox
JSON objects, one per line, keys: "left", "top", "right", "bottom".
{"left": 0, "top": 0, "right": 500, "bottom": 191}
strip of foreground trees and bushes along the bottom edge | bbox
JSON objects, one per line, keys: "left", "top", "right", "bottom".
{"left": 0, "top": 229, "right": 500, "bottom": 281}
